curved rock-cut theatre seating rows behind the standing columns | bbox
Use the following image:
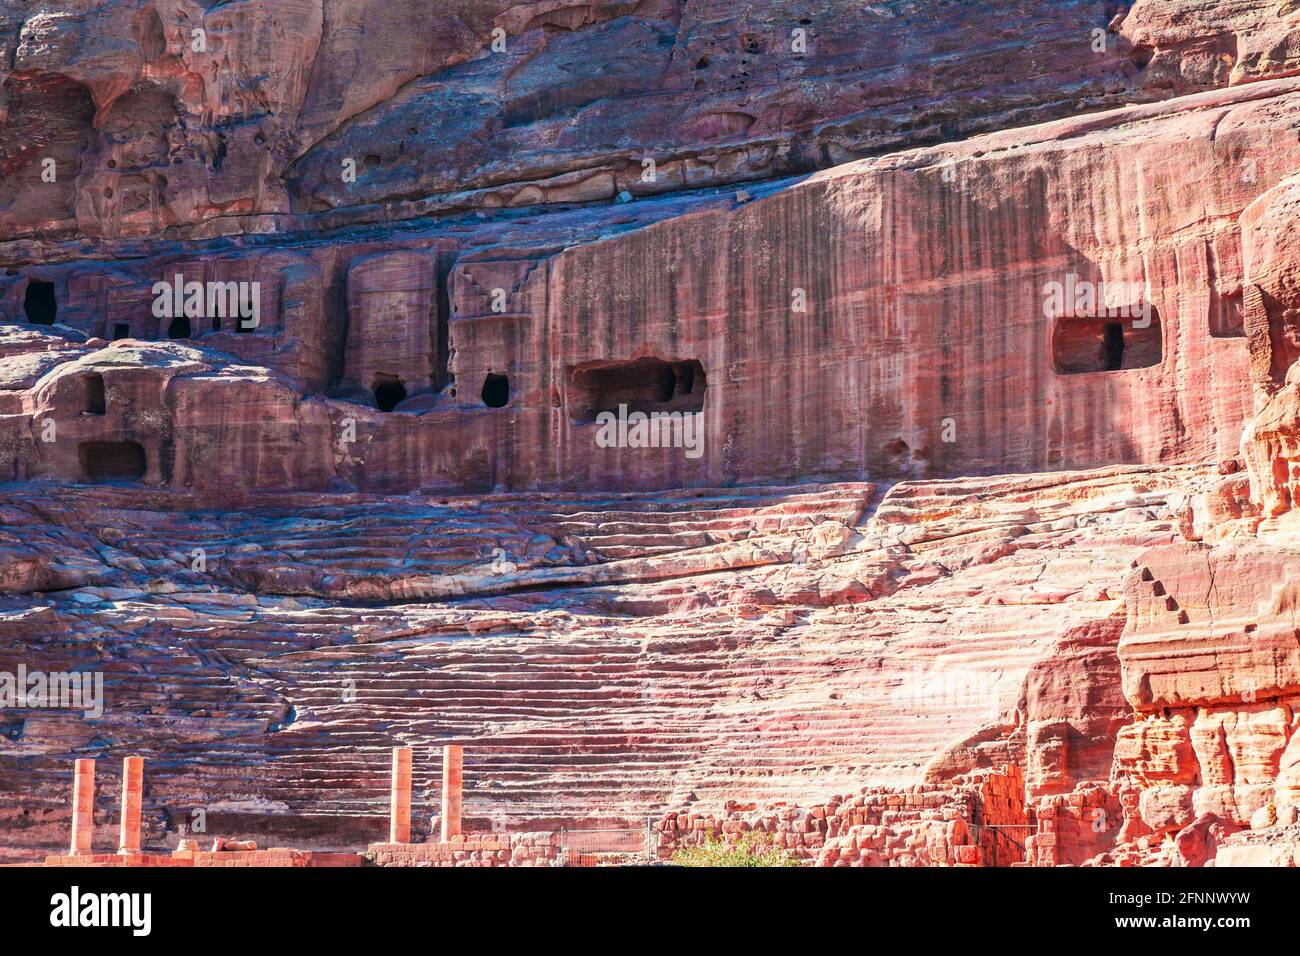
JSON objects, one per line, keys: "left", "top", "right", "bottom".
{"left": 3, "top": 468, "right": 1208, "bottom": 858}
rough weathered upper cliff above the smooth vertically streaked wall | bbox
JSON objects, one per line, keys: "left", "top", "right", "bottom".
{"left": 0, "top": 0, "right": 1300, "bottom": 237}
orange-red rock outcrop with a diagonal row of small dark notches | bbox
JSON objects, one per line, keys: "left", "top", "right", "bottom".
{"left": 1115, "top": 542, "right": 1300, "bottom": 831}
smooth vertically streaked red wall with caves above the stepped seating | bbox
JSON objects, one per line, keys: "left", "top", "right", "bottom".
{"left": 0, "top": 81, "right": 1300, "bottom": 490}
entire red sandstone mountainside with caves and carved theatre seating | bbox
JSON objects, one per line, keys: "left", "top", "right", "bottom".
{"left": 0, "top": 0, "right": 1300, "bottom": 866}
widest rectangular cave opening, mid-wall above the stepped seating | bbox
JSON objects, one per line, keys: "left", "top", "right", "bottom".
{"left": 568, "top": 359, "right": 709, "bottom": 421}
